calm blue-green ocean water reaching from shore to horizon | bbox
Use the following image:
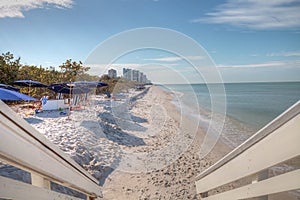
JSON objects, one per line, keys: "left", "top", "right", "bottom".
{"left": 163, "top": 82, "right": 300, "bottom": 147}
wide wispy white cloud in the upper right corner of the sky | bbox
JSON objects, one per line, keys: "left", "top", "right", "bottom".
{"left": 191, "top": 0, "right": 300, "bottom": 30}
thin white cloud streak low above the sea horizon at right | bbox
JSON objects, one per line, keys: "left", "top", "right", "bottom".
{"left": 217, "top": 60, "right": 300, "bottom": 69}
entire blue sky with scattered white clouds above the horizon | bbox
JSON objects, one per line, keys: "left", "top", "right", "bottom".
{"left": 0, "top": 0, "right": 300, "bottom": 83}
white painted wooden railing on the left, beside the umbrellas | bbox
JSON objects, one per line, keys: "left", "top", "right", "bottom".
{"left": 0, "top": 101, "right": 102, "bottom": 199}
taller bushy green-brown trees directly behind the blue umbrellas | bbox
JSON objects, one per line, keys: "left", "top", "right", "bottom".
{"left": 0, "top": 52, "right": 110, "bottom": 97}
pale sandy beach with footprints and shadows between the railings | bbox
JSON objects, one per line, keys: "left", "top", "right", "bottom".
{"left": 0, "top": 86, "right": 298, "bottom": 200}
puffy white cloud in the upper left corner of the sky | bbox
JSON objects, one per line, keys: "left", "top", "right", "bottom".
{"left": 0, "top": 0, "right": 73, "bottom": 18}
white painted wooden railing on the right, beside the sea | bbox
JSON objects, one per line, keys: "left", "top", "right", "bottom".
{"left": 196, "top": 101, "right": 300, "bottom": 200}
